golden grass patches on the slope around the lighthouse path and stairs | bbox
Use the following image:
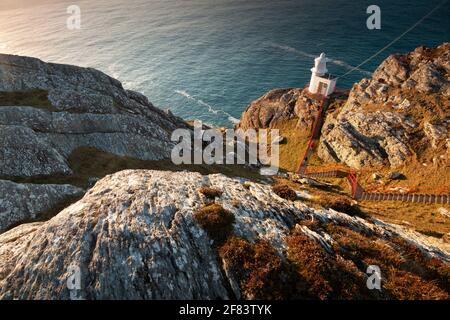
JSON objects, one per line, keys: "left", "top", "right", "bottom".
{"left": 268, "top": 89, "right": 450, "bottom": 238}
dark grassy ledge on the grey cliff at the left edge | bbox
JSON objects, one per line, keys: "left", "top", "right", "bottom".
{"left": 0, "top": 90, "right": 58, "bottom": 111}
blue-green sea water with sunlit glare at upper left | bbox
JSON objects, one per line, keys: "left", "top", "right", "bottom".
{"left": 0, "top": 0, "right": 450, "bottom": 126}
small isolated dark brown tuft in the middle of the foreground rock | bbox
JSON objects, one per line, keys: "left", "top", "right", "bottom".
{"left": 194, "top": 203, "right": 234, "bottom": 245}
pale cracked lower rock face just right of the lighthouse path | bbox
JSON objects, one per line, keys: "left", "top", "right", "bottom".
{"left": 318, "top": 111, "right": 411, "bottom": 169}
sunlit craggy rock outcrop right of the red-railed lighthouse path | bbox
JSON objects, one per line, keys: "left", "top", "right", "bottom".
{"left": 318, "top": 43, "right": 450, "bottom": 168}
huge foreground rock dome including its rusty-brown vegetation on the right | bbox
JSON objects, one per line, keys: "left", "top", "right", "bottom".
{"left": 0, "top": 170, "right": 450, "bottom": 299}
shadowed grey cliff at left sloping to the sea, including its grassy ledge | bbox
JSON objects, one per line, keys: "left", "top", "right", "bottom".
{"left": 0, "top": 54, "right": 186, "bottom": 231}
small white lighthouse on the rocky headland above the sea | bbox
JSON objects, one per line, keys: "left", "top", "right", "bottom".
{"left": 309, "top": 53, "right": 336, "bottom": 97}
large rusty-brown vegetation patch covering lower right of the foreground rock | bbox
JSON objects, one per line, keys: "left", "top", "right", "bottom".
{"left": 218, "top": 221, "right": 450, "bottom": 300}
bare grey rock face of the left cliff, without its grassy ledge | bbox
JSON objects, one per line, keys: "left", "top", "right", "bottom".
{"left": 0, "top": 55, "right": 186, "bottom": 171}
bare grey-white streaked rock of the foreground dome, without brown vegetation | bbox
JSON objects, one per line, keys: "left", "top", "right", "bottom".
{"left": 0, "top": 170, "right": 450, "bottom": 299}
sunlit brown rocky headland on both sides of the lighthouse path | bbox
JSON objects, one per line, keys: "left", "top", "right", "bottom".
{"left": 239, "top": 43, "right": 450, "bottom": 169}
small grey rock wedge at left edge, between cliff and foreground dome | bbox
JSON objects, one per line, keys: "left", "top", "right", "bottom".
{"left": 0, "top": 180, "right": 84, "bottom": 232}
